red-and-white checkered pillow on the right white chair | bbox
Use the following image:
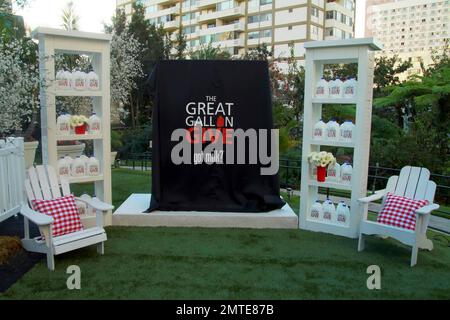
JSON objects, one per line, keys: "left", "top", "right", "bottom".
{"left": 377, "top": 192, "right": 428, "bottom": 230}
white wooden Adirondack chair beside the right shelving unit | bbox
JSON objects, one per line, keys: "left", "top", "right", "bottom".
{"left": 358, "top": 167, "right": 439, "bottom": 267}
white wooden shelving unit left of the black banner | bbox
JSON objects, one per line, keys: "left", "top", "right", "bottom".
{"left": 33, "top": 28, "right": 112, "bottom": 226}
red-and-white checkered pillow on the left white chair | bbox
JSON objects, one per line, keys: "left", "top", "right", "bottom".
{"left": 33, "top": 196, "right": 83, "bottom": 237}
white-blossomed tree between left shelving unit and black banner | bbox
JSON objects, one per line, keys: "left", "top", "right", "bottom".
{"left": 111, "top": 29, "right": 144, "bottom": 119}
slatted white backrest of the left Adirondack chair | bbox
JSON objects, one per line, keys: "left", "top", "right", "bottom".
{"left": 25, "top": 166, "right": 70, "bottom": 205}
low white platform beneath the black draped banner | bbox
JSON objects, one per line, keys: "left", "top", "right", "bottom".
{"left": 113, "top": 194, "right": 298, "bottom": 229}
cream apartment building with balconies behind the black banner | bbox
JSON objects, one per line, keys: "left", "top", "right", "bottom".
{"left": 117, "top": 0, "right": 355, "bottom": 60}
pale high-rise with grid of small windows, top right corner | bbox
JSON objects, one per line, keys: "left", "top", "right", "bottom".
{"left": 365, "top": 0, "right": 450, "bottom": 77}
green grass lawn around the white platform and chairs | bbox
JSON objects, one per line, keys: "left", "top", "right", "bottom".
{"left": 0, "top": 170, "right": 450, "bottom": 299}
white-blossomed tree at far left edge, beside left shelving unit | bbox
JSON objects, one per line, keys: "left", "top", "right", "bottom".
{"left": 0, "top": 39, "right": 39, "bottom": 135}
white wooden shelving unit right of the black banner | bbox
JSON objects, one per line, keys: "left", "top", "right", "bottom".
{"left": 300, "top": 38, "right": 381, "bottom": 238}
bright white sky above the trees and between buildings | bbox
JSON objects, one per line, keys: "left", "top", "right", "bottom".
{"left": 16, "top": 0, "right": 366, "bottom": 38}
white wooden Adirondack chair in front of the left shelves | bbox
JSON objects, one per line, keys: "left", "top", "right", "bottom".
{"left": 20, "top": 166, "right": 114, "bottom": 270}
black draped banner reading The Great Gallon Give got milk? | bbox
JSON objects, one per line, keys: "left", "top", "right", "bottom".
{"left": 149, "top": 61, "right": 284, "bottom": 212}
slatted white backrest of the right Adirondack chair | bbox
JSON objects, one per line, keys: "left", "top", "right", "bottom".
{"left": 386, "top": 166, "right": 436, "bottom": 203}
